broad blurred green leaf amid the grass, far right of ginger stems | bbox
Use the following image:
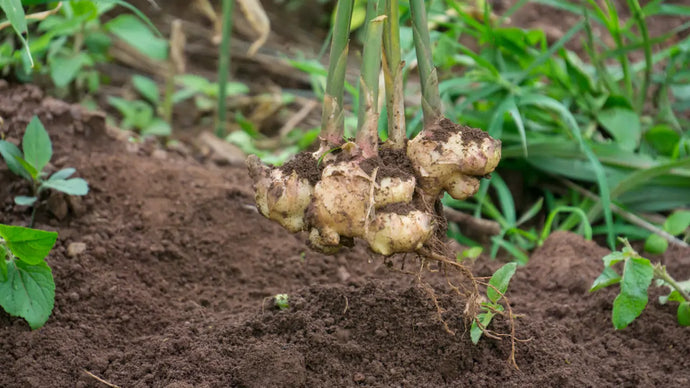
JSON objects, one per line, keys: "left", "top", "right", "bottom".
{"left": 597, "top": 107, "right": 642, "bottom": 151}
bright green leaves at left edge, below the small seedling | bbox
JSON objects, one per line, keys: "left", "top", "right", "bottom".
{"left": 0, "top": 224, "right": 57, "bottom": 329}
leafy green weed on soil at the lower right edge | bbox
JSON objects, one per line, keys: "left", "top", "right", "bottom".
{"left": 590, "top": 239, "right": 690, "bottom": 330}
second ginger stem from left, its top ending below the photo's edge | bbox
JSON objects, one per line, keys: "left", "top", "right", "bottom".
{"left": 357, "top": 14, "right": 386, "bottom": 158}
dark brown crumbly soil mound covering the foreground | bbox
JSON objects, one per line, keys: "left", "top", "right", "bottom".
{"left": 0, "top": 85, "right": 690, "bottom": 388}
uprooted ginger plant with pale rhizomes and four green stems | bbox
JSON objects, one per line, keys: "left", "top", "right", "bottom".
{"left": 247, "top": 0, "right": 501, "bottom": 255}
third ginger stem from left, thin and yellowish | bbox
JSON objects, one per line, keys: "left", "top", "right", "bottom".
{"left": 379, "top": 0, "right": 406, "bottom": 149}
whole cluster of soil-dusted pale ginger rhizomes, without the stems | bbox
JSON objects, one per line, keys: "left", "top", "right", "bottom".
{"left": 247, "top": 119, "right": 501, "bottom": 255}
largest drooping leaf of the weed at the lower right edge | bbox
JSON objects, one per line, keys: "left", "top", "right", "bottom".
{"left": 612, "top": 257, "right": 654, "bottom": 330}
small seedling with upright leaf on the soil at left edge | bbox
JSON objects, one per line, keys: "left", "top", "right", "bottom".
{"left": 0, "top": 116, "right": 89, "bottom": 226}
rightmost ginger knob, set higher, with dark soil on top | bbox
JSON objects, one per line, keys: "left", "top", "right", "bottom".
{"left": 407, "top": 125, "right": 501, "bottom": 199}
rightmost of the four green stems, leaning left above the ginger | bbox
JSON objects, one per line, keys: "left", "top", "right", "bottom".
{"left": 410, "top": 0, "right": 442, "bottom": 126}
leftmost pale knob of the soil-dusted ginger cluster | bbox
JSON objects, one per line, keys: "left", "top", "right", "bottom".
{"left": 247, "top": 155, "right": 314, "bottom": 233}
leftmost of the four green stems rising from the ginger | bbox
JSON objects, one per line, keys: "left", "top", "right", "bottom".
{"left": 320, "top": 0, "right": 355, "bottom": 149}
